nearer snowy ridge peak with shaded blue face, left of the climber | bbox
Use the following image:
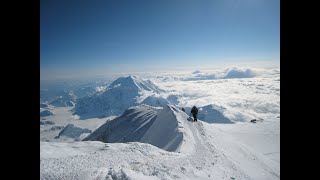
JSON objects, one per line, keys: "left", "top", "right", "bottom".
{"left": 84, "top": 105, "right": 194, "bottom": 152}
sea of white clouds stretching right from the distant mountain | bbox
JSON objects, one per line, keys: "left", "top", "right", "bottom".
{"left": 148, "top": 67, "right": 280, "bottom": 121}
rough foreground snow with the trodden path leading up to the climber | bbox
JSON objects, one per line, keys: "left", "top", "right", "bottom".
{"left": 40, "top": 113, "right": 250, "bottom": 179}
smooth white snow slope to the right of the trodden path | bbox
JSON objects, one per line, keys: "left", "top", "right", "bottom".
{"left": 205, "top": 121, "right": 280, "bottom": 180}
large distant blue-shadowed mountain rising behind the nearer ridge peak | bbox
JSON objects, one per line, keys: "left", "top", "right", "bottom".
{"left": 74, "top": 76, "right": 163, "bottom": 119}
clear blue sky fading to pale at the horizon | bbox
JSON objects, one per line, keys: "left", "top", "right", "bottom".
{"left": 40, "top": 0, "right": 280, "bottom": 79}
